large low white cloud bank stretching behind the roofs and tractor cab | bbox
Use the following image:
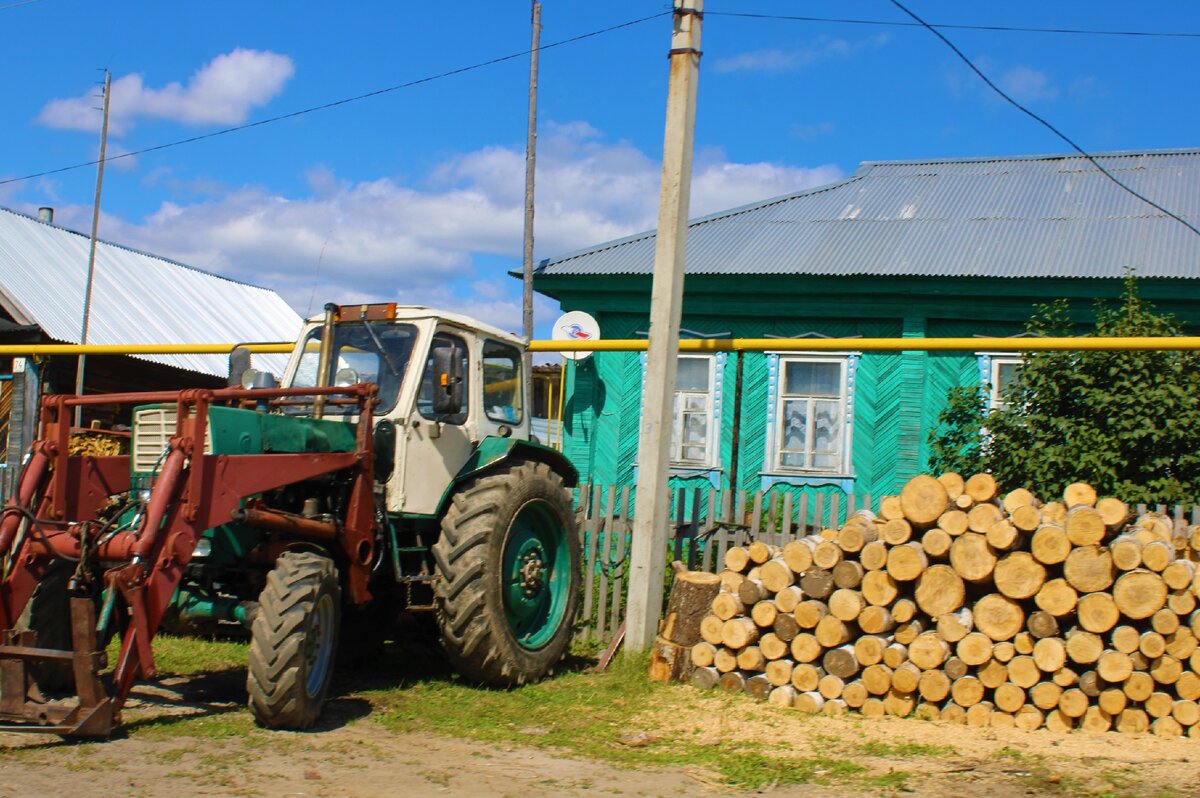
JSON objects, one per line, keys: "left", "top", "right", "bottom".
{"left": 39, "top": 125, "right": 842, "bottom": 329}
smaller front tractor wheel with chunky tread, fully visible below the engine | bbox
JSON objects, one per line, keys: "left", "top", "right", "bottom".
{"left": 246, "top": 552, "right": 342, "bottom": 728}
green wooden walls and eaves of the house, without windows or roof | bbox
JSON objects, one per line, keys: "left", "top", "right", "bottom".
{"left": 536, "top": 276, "right": 1200, "bottom": 511}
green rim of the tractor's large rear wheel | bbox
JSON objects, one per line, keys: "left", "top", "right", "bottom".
{"left": 500, "top": 499, "right": 571, "bottom": 649}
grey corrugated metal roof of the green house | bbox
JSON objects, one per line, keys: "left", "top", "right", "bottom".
{"left": 538, "top": 150, "right": 1200, "bottom": 280}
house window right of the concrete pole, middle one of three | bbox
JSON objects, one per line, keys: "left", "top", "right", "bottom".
{"left": 774, "top": 356, "right": 847, "bottom": 473}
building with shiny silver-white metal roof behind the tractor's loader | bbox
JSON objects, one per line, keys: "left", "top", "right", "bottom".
{"left": 0, "top": 209, "right": 302, "bottom": 472}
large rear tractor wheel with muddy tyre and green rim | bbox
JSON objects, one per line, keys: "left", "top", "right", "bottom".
{"left": 433, "top": 462, "right": 580, "bottom": 686}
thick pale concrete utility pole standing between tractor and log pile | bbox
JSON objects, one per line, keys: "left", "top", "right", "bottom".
{"left": 625, "top": 0, "right": 704, "bottom": 653}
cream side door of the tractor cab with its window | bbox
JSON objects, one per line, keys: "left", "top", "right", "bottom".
{"left": 402, "top": 331, "right": 474, "bottom": 514}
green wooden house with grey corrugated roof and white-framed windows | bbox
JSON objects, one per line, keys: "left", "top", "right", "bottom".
{"left": 534, "top": 150, "right": 1200, "bottom": 511}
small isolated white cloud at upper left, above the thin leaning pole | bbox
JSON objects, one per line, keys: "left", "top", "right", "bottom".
{"left": 37, "top": 48, "right": 295, "bottom": 134}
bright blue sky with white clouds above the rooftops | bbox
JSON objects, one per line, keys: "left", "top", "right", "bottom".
{"left": 0, "top": 0, "right": 1200, "bottom": 335}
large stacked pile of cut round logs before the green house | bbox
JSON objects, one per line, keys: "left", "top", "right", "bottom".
{"left": 690, "top": 474, "right": 1200, "bottom": 738}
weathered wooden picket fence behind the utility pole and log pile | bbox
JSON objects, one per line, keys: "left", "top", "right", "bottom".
{"left": 576, "top": 485, "right": 1200, "bottom": 646}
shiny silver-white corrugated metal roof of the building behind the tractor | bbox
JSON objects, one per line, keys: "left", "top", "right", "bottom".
{"left": 0, "top": 208, "right": 301, "bottom": 377}
